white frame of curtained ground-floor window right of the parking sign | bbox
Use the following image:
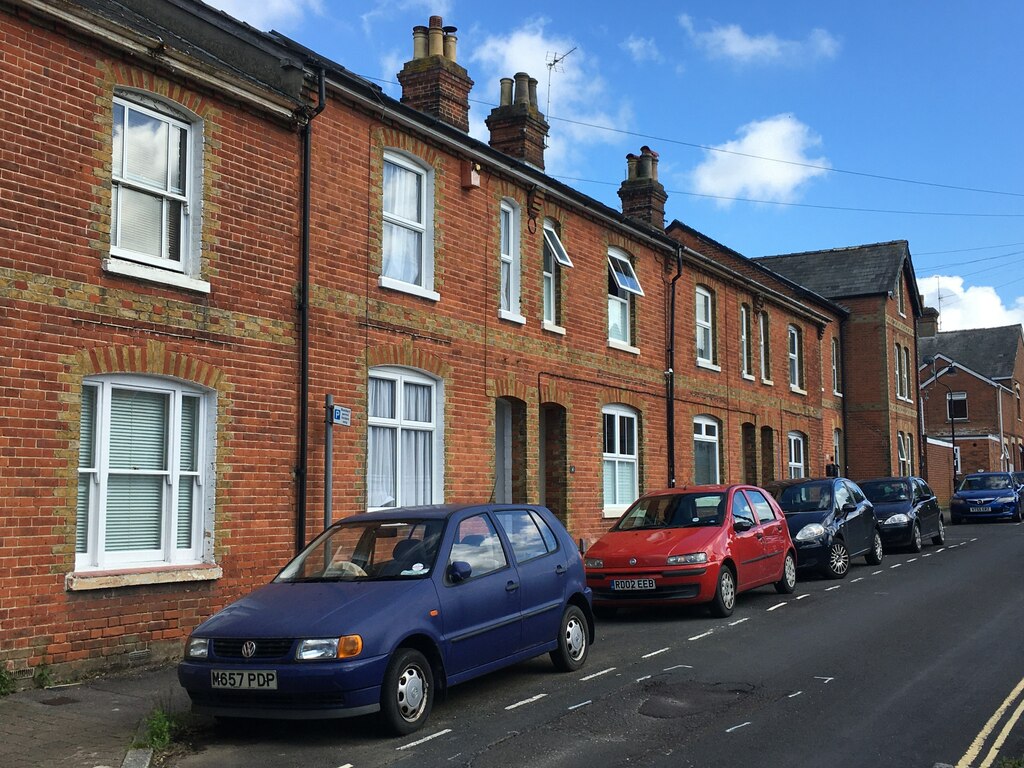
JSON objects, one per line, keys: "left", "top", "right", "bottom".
{"left": 367, "top": 366, "right": 444, "bottom": 511}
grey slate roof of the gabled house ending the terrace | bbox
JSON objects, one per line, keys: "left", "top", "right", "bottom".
{"left": 755, "top": 240, "right": 916, "bottom": 309}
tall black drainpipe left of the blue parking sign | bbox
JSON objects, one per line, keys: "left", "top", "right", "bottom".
{"left": 295, "top": 67, "right": 327, "bottom": 553}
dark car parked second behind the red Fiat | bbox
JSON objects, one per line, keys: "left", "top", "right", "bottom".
{"left": 858, "top": 477, "right": 946, "bottom": 552}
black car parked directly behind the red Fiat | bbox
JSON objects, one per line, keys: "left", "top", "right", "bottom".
{"left": 765, "top": 477, "right": 884, "bottom": 579}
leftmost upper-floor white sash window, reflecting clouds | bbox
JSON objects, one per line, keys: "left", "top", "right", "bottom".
{"left": 111, "top": 95, "right": 198, "bottom": 272}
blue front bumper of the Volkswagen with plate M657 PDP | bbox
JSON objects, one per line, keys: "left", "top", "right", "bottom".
{"left": 178, "top": 655, "right": 388, "bottom": 720}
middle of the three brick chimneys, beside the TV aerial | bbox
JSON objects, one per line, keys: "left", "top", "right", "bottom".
{"left": 484, "top": 72, "right": 548, "bottom": 171}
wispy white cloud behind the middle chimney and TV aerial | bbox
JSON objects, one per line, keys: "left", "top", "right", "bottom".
{"left": 467, "top": 18, "right": 633, "bottom": 175}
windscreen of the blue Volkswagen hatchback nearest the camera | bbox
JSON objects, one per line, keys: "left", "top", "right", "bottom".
{"left": 274, "top": 518, "right": 444, "bottom": 583}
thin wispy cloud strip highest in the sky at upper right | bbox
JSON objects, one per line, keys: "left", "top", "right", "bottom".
{"left": 679, "top": 14, "right": 840, "bottom": 65}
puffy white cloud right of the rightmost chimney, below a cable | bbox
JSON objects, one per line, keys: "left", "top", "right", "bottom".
{"left": 692, "top": 115, "right": 829, "bottom": 207}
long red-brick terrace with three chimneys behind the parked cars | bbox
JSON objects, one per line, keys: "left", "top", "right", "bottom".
{"left": 0, "top": 0, "right": 920, "bottom": 679}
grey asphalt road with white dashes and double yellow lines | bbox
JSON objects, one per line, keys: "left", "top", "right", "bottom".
{"left": 173, "top": 523, "right": 1024, "bottom": 768}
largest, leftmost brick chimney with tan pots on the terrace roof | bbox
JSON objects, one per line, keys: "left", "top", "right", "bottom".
{"left": 398, "top": 16, "right": 473, "bottom": 132}
